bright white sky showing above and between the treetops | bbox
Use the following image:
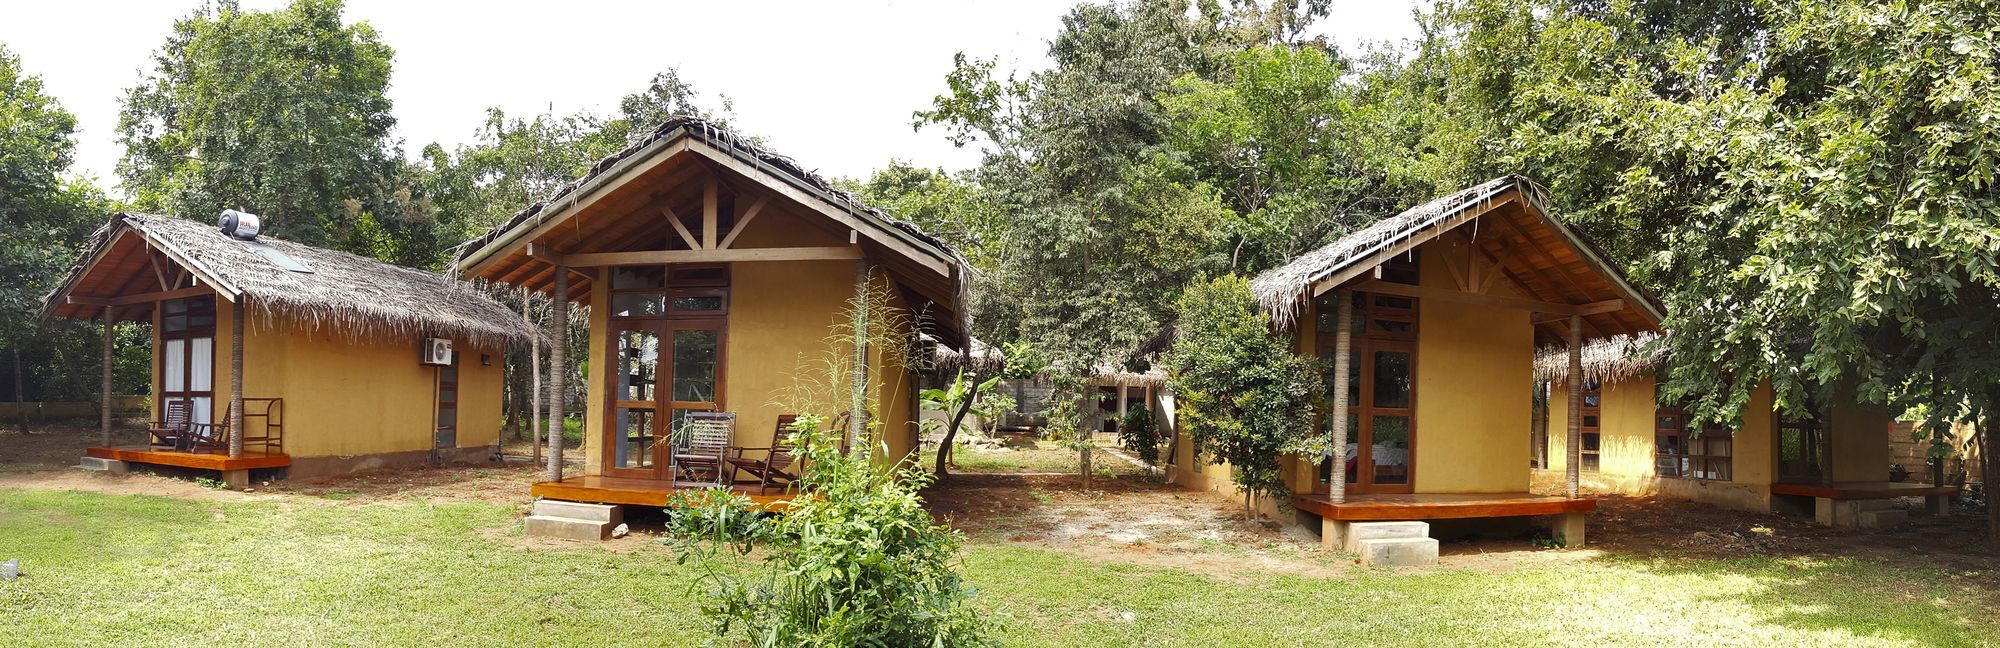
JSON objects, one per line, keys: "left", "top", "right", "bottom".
{"left": 0, "top": 0, "right": 1424, "bottom": 192}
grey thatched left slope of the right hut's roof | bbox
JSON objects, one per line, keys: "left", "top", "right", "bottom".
{"left": 1250, "top": 174, "right": 1546, "bottom": 326}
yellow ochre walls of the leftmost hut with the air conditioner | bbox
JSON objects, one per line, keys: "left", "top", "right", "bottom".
{"left": 152, "top": 292, "right": 502, "bottom": 458}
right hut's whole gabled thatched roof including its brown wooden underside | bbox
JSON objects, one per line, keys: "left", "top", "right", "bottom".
{"left": 1250, "top": 176, "right": 1666, "bottom": 342}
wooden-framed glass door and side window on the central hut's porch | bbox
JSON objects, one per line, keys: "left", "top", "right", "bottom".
{"left": 604, "top": 318, "right": 726, "bottom": 480}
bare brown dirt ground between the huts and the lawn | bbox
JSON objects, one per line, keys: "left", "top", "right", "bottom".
{"left": 0, "top": 426, "right": 2000, "bottom": 590}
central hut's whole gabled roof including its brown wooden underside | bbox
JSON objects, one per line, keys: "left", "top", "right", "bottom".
{"left": 454, "top": 116, "right": 972, "bottom": 346}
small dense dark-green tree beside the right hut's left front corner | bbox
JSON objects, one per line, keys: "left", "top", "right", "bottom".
{"left": 1164, "top": 276, "right": 1324, "bottom": 512}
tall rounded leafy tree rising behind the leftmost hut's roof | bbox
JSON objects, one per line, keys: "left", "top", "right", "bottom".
{"left": 118, "top": 0, "right": 410, "bottom": 252}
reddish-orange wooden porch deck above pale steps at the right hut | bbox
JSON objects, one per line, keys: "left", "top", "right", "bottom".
{"left": 1292, "top": 492, "right": 1598, "bottom": 520}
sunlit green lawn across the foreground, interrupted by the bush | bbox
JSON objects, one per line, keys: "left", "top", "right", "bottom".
{"left": 0, "top": 490, "right": 2000, "bottom": 646}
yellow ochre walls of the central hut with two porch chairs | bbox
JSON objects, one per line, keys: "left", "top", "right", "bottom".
{"left": 582, "top": 204, "right": 916, "bottom": 474}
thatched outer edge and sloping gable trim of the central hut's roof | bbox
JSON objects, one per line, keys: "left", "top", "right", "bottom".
{"left": 454, "top": 116, "right": 972, "bottom": 342}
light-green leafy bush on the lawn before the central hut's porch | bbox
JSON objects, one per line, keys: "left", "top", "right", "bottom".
{"left": 668, "top": 416, "right": 992, "bottom": 646}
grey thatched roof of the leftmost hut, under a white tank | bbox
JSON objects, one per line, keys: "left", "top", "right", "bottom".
{"left": 42, "top": 212, "right": 532, "bottom": 344}
